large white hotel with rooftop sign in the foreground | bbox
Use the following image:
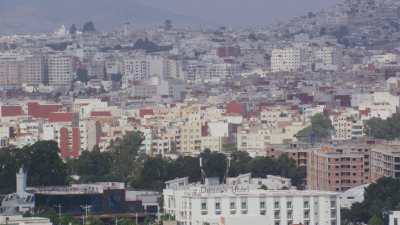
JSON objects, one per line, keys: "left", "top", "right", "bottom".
{"left": 163, "top": 178, "right": 340, "bottom": 225}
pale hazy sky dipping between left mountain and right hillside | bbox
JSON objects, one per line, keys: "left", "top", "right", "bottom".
{"left": 137, "top": 0, "right": 339, "bottom": 25}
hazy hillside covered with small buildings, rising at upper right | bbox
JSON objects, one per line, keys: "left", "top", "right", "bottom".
{"left": 275, "top": 0, "right": 400, "bottom": 47}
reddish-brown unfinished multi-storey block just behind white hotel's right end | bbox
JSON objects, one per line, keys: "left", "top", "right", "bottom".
{"left": 307, "top": 145, "right": 371, "bottom": 191}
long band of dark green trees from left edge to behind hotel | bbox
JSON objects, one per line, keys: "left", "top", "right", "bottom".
{"left": 0, "top": 132, "right": 305, "bottom": 193}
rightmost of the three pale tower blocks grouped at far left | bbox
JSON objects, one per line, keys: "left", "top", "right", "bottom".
{"left": 47, "top": 53, "right": 73, "bottom": 86}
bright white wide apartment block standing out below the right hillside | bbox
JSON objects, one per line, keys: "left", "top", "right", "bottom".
{"left": 271, "top": 48, "right": 308, "bottom": 72}
